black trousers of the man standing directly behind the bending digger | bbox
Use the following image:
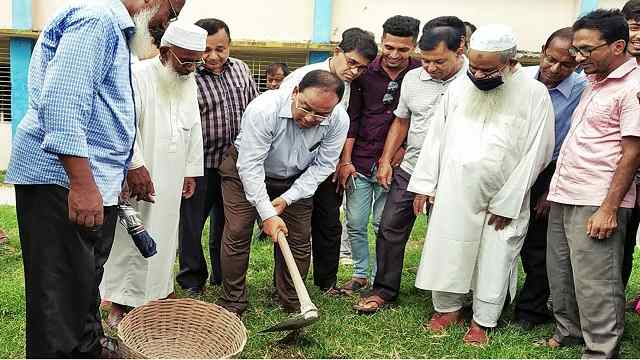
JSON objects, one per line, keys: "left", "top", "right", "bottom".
{"left": 311, "top": 175, "right": 343, "bottom": 290}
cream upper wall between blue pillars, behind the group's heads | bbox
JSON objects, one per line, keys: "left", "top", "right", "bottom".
{"left": 22, "top": 0, "right": 625, "bottom": 51}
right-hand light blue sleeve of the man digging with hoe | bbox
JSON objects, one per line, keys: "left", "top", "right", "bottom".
{"left": 281, "top": 106, "right": 349, "bottom": 205}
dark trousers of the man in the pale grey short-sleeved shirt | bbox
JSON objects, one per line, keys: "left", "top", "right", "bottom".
{"left": 373, "top": 168, "right": 416, "bottom": 301}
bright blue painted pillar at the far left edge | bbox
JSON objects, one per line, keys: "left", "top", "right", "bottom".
{"left": 9, "top": 0, "right": 33, "bottom": 133}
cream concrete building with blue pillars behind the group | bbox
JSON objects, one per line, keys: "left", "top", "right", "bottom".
{"left": 0, "top": 0, "right": 625, "bottom": 169}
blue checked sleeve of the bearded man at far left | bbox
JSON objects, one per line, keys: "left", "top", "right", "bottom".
{"left": 38, "top": 16, "right": 117, "bottom": 157}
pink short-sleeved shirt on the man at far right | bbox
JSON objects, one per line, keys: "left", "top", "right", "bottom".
{"left": 548, "top": 59, "right": 640, "bottom": 208}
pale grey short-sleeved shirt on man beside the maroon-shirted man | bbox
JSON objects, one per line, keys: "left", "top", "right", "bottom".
{"left": 394, "top": 58, "right": 468, "bottom": 174}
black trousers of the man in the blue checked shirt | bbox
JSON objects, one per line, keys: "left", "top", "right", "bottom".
{"left": 15, "top": 185, "right": 117, "bottom": 358}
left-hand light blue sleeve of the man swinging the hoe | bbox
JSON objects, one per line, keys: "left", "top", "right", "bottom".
{"left": 236, "top": 103, "right": 278, "bottom": 220}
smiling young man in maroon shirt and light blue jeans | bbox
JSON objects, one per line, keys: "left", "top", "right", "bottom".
{"left": 337, "top": 15, "right": 420, "bottom": 294}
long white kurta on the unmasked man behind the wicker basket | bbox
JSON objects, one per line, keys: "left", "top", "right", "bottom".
{"left": 100, "top": 57, "right": 204, "bottom": 306}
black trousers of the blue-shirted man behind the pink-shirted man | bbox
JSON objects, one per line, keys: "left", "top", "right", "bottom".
{"left": 515, "top": 162, "right": 556, "bottom": 324}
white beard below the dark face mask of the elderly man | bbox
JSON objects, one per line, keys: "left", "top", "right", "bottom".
{"left": 460, "top": 71, "right": 514, "bottom": 120}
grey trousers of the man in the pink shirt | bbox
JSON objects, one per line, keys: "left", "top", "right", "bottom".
{"left": 547, "top": 203, "right": 631, "bottom": 358}
